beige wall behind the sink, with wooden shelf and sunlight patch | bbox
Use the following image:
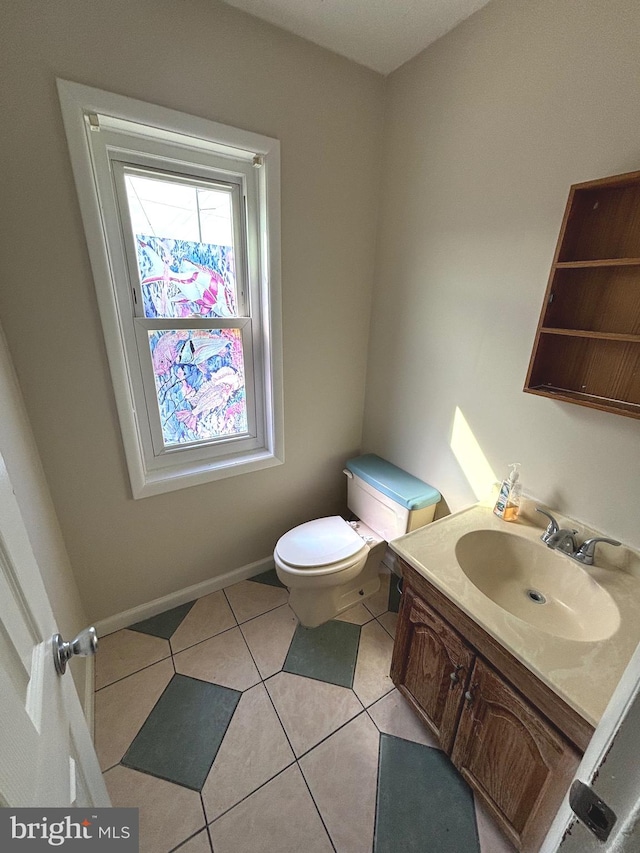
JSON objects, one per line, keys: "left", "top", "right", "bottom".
{"left": 364, "top": 0, "right": 640, "bottom": 546}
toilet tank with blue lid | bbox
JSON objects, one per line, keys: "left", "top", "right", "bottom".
{"left": 344, "top": 453, "right": 441, "bottom": 542}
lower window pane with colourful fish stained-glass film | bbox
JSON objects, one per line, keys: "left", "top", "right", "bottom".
{"left": 148, "top": 329, "right": 247, "bottom": 447}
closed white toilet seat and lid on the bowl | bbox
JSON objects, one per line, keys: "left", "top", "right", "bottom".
{"left": 274, "top": 515, "right": 369, "bottom": 576}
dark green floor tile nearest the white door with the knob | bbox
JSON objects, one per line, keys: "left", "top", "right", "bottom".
{"left": 122, "top": 675, "right": 242, "bottom": 791}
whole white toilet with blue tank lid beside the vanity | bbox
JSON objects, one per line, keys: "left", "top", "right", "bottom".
{"left": 273, "top": 453, "right": 440, "bottom": 628}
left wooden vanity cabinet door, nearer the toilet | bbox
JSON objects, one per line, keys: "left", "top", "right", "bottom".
{"left": 391, "top": 588, "right": 473, "bottom": 754}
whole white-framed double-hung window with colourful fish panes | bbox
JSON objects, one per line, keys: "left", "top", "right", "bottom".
{"left": 58, "top": 81, "right": 283, "bottom": 498}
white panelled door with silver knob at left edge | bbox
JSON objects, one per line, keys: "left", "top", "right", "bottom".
{"left": 0, "top": 446, "right": 110, "bottom": 807}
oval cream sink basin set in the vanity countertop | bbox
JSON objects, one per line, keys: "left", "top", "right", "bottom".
{"left": 455, "top": 530, "right": 620, "bottom": 642}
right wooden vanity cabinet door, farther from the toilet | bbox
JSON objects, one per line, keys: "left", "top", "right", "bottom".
{"left": 451, "top": 658, "right": 580, "bottom": 853}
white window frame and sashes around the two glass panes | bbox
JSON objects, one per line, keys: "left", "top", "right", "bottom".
{"left": 57, "top": 80, "right": 284, "bottom": 498}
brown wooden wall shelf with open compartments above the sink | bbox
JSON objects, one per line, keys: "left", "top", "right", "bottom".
{"left": 524, "top": 172, "right": 640, "bottom": 418}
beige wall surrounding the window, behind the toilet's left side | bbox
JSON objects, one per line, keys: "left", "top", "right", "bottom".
{"left": 0, "top": 0, "right": 383, "bottom": 620}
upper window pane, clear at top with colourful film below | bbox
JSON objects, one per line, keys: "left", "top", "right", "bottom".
{"left": 125, "top": 174, "right": 237, "bottom": 318}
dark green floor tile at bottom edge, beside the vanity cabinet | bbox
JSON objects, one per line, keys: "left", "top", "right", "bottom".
{"left": 373, "top": 734, "right": 480, "bottom": 853}
